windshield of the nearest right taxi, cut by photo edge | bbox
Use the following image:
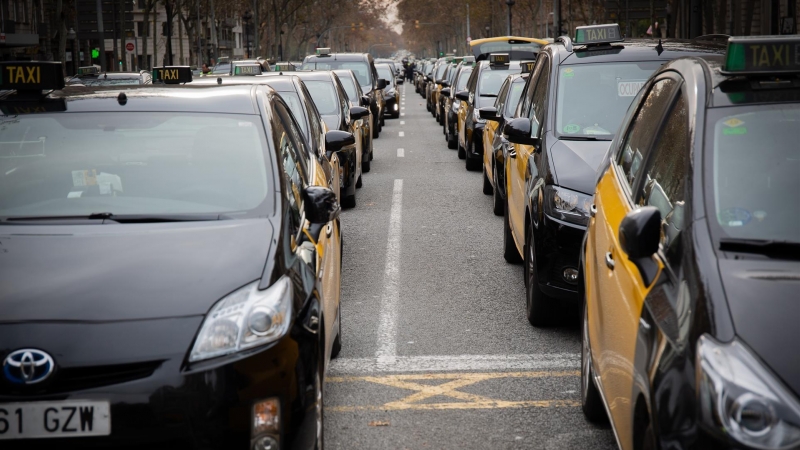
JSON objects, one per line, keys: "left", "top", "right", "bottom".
{"left": 706, "top": 104, "right": 800, "bottom": 242}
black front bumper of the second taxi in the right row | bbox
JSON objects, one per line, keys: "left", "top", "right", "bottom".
{"left": 536, "top": 214, "right": 586, "bottom": 301}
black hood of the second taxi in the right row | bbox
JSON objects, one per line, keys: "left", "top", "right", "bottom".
{"left": 550, "top": 140, "right": 611, "bottom": 195}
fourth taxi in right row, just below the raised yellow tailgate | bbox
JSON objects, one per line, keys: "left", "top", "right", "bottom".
{"left": 456, "top": 53, "right": 524, "bottom": 170}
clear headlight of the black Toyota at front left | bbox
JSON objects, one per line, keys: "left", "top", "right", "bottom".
{"left": 189, "top": 276, "right": 292, "bottom": 362}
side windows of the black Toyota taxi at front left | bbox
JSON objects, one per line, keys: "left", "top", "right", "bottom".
{"left": 272, "top": 102, "right": 307, "bottom": 234}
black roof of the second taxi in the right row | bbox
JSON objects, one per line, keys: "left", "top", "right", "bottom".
{"left": 546, "top": 39, "right": 725, "bottom": 65}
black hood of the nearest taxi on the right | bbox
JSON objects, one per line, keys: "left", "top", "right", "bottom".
{"left": 719, "top": 259, "right": 800, "bottom": 396}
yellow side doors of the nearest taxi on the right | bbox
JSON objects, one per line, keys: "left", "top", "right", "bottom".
{"left": 586, "top": 75, "right": 688, "bottom": 449}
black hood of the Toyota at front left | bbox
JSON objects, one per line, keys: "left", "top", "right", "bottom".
{"left": 0, "top": 219, "right": 275, "bottom": 323}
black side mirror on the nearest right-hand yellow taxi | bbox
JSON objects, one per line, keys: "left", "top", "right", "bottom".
{"left": 619, "top": 206, "right": 661, "bottom": 286}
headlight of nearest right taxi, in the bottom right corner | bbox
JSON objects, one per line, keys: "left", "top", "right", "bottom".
{"left": 695, "top": 334, "right": 800, "bottom": 449}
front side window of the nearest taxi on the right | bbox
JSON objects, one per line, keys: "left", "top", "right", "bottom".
{"left": 636, "top": 95, "right": 689, "bottom": 273}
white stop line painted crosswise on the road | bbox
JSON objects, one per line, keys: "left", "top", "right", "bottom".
{"left": 329, "top": 354, "right": 581, "bottom": 374}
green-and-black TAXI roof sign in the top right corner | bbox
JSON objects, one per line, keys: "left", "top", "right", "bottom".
{"left": 720, "top": 35, "right": 800, "bottom": 75}
